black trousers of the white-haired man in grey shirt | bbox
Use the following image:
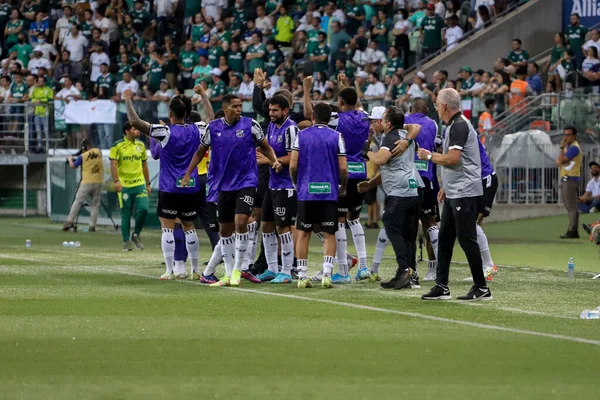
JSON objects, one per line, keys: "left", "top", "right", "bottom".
{"left": 436, "top": 197, "right": 486, "bottom": 287}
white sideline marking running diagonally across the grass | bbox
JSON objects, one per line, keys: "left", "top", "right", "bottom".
{"left": 62, "top": 266, "right": 600, "bottom": 346}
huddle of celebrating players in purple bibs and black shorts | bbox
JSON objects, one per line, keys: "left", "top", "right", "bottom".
{"left": 119, "top": 79, "right": 497, "bottom": 298}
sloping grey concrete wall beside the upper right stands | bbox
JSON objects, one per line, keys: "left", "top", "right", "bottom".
{"left": 421, "top": 0, "right": 563, "bottom": 79}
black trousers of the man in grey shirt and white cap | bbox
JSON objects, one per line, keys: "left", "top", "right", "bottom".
{"left": 383, "top": 196, "right": 420, "bottom": 270}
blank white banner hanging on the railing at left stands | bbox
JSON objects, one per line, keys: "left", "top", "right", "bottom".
{"left": 54, "top": 100, "right": 117, "bottom": 125}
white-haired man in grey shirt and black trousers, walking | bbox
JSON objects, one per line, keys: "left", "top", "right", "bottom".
{"left": 418, "top": 89, "right": 492, "bottom": 301}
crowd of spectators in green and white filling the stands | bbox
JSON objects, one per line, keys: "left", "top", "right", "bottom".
{"left": 0, "top": 0, "right": 599, "bottom": 153}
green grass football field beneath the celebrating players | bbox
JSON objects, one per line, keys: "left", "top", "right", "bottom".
{"left": 0, "top": 216, "right": 600, "bottom": 400}
